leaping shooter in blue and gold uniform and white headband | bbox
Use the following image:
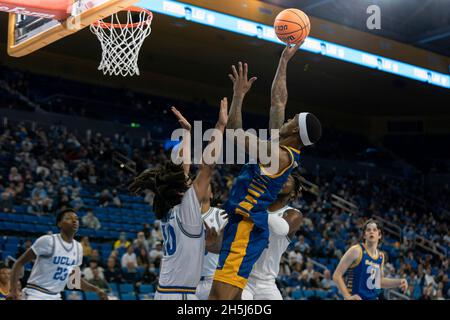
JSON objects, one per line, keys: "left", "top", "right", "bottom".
{"left": 209, "top": 44, "right": 322, "bottom": 300}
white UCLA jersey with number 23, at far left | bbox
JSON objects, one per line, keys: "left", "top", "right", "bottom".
{"left": 23, "top": 234, "right": 83, "bottom": 300}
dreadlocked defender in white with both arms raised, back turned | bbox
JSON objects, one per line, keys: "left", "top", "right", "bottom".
{"left": 129, "top": 98, "right": 228, "bottom": 300}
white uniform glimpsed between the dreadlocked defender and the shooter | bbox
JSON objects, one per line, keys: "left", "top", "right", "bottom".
{"left": 195, "top": 207, "right": 227, "bottom": 300}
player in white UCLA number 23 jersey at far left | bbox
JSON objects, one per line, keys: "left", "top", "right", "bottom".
{"left": 8, "top": 208, "right": 107, "bottom": 300}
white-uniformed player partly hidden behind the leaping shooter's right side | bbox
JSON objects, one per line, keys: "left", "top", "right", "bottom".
{"left": 242, "top": 172, "right": 302, "bottom": 300}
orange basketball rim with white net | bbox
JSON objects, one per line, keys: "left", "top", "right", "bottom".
{"left": 91, "top": 7, "right": 153, "bottom": 77}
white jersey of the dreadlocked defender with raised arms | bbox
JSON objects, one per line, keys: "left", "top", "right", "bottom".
{"left": 155, "top": 187, "right": 205, "bottom": 300}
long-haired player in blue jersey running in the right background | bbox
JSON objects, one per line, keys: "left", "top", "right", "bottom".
{"left": 333, "top": 219, "right": 408, "bottom": 300}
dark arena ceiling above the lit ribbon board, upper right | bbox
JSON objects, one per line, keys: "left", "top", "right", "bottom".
{"left": 262, "top": 0, "right": 450, "bottom": 56}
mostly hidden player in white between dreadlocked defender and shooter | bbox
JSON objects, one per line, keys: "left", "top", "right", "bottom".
{"left": 195, "top": 188, "right": 227, "bottom": 300}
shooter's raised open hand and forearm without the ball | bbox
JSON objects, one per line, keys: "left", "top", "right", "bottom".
{"left": 227, "top": 62, "right": 257, "bottom": 129}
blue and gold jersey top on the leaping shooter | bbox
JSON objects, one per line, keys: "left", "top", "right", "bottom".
{"left": 223, "top": 146, "right": 300, "bottom": 230}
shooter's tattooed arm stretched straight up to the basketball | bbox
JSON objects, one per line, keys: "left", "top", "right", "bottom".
{"left": 269, "top": 42, "right": 303, "bottom": 130}
